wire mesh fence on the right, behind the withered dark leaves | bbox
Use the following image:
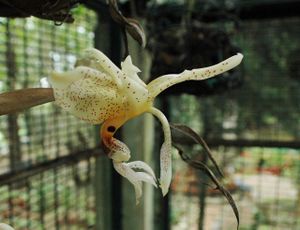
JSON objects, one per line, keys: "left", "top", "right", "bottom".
{"left": 170, "top": 18, "right": 300, "bottom": 230}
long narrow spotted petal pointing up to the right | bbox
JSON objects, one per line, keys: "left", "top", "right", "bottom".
{"left": 147, "top": 53, "right": 243, "bottom": 99}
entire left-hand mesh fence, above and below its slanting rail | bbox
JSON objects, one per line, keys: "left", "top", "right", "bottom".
{"left": 0, "top": 7, "right": 99, "bottom": 230}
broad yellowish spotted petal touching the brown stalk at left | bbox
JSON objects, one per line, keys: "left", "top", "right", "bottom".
{"left": 49, "top": 66, "right": 126, "bottom": 124}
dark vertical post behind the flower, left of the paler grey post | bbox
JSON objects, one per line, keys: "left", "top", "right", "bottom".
{"left": 95, "top": 9, "right": 122, "bottom": 230}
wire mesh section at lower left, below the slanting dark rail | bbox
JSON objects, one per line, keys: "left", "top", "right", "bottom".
{"left": 0, "top": 161, "right": 95, "bottom": 229}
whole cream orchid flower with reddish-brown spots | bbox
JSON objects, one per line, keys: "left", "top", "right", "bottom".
{"left": 49, "top": 49, "right": 243, "bottom": 203}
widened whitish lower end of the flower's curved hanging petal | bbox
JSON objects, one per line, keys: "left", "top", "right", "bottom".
{"left": 159, "top": 142, "right": 172, "bottom": 196}
